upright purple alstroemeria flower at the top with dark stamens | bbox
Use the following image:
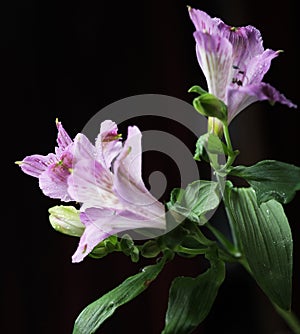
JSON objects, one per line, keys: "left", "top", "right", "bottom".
{"left": 189, "top": 8, "right": 297, "bottom": 128}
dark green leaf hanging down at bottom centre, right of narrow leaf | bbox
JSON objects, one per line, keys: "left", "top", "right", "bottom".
{"left": 162, "top": 260, "right": 225, "bottom": 334}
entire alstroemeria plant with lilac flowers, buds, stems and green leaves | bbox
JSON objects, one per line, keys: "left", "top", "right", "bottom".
{"left": 17, "top": 8, "right": 300, "bottom": 334}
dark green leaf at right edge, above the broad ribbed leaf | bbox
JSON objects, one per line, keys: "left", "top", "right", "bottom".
{"left": 230, "top": 160, "right": 300, "bottom": 204}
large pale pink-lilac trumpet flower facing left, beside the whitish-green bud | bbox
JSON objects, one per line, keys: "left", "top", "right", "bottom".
{"left": 68, "top": 121, "right": 166, "bottom": 262}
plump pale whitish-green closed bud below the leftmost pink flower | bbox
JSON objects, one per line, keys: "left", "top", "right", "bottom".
{"left": 48, "top": 205, "right": 85, "bottom": 237}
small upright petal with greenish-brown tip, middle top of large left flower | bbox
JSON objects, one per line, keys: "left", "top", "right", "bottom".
{"left": 95, "top": 120, "right": 122, "bottom": 169}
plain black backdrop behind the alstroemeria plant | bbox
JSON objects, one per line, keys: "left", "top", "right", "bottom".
{"left": 4, "top": 0, "right": 300, "bottom": 334}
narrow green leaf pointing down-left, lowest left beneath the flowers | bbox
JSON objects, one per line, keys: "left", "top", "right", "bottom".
{"left": 72, "top": 253, "right": 169, "bottom": 334}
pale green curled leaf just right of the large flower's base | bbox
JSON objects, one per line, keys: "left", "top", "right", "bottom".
{"left": 169, "top": 180, "right": 220, "bottom": 225}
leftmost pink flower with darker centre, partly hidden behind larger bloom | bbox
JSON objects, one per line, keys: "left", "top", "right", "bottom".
{"left": 17, "top": 121, "right": 73, "bottom": 202}
